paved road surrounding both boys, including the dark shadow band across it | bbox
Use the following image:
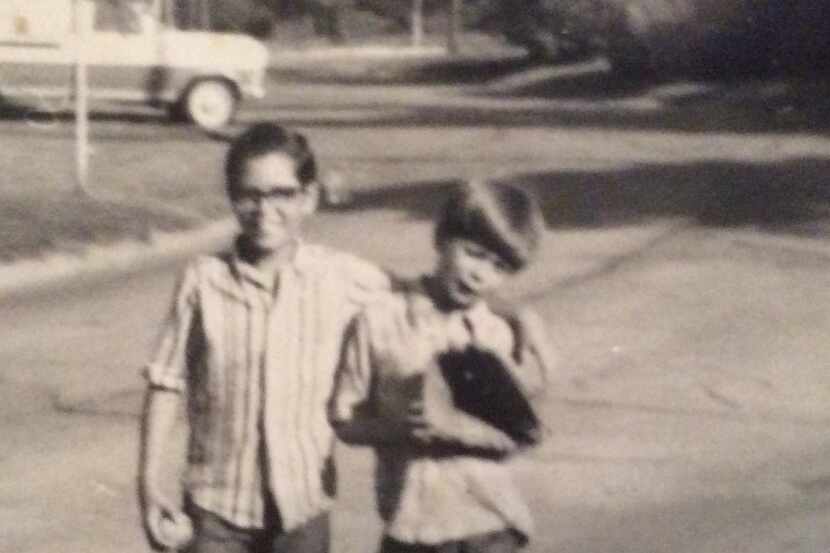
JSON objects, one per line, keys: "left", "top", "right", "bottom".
{"left": 0, "top": 67, "right": 830, "bottom": 553}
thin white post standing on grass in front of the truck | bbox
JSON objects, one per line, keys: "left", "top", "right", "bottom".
{"left": 75, "top": 0, "right": 89, "bottom": 192}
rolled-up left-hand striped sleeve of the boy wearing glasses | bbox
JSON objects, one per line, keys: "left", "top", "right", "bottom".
{"left": 143, "top": 265, "right": 197, "bottom": 392}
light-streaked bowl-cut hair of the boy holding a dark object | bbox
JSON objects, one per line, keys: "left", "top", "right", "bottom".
{"left": 434, "top": 180, "right": 544, "bottom": 271}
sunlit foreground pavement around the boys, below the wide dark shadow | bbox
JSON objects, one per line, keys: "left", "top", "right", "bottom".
{"left": 0, "top": 198, "right": 830, "bottom": 553}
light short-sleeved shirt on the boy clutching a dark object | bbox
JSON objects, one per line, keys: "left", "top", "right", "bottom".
{"left": 330, "top": 278, "right": 546, "bottom": 544}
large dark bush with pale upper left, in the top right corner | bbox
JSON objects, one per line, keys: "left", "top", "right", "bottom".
{"left": 606, "top": 0, "right": 830, "bottom": 78}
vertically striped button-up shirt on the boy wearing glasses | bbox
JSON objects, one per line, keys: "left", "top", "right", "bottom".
{"left": 146, "top": 244, "right": 388, "bottom": 530}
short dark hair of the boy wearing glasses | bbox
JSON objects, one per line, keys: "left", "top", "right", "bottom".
{"left": 225, "top": 122, "right": 317, "bottom": 198}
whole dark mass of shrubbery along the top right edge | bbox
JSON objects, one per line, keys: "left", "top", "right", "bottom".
{"left": 462, "top": 0, "right": 830, "bottom": 78}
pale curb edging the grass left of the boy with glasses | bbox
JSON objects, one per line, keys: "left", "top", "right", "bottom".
{"left": 0, "top": 217, "right": 236, "bottom": 298}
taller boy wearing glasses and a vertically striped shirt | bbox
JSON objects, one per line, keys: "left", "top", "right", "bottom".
{"left": 139, "top": 123, "right": 389, "bottom": 553}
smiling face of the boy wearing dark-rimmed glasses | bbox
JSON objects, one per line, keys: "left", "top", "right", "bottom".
{"left": 231, "top": 152, "right": 317, "bottom": 253}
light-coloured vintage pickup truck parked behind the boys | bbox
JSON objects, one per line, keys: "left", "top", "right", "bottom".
{"left": 0, "top": 0, "right": 268, "bottom": 130}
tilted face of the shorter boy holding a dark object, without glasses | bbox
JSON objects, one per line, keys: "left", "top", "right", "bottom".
{"left": 436, "top": 238, "right": 512, "bottom": 307}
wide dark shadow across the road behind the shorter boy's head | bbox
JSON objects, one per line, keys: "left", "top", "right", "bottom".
{"left": 338, "top": 159, "right": 830, "bottom": 236}
